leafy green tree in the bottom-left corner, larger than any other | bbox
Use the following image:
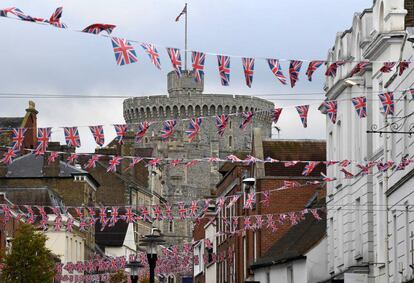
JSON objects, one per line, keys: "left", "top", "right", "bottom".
{"left": 1, "top": 224, "right": 55, "bottom": 283}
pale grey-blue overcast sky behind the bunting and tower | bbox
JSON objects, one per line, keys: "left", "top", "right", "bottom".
{"left": 0, "top": 0, "right": 373, "bottom": 151}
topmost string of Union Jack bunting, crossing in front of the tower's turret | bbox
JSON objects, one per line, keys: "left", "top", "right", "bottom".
{"left": 0, "top": 7, "right": 412, "bottom": 88}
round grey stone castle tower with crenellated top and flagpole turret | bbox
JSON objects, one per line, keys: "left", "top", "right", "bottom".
{"left": 124, "top": 72, "right": 274, "bottom": 244}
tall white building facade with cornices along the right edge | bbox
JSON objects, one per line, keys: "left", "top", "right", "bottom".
{"left": 325, "top": 0, "right": 414, "bottom": 282}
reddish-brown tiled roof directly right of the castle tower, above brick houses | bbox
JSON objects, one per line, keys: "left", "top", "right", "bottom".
{"left": 263, "top": 140, "right": 326, "bottom": 177}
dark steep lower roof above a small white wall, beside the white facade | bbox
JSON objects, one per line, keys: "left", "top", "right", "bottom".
{"left": 251, "top": 211, "right": 326, "bottom": 269}
